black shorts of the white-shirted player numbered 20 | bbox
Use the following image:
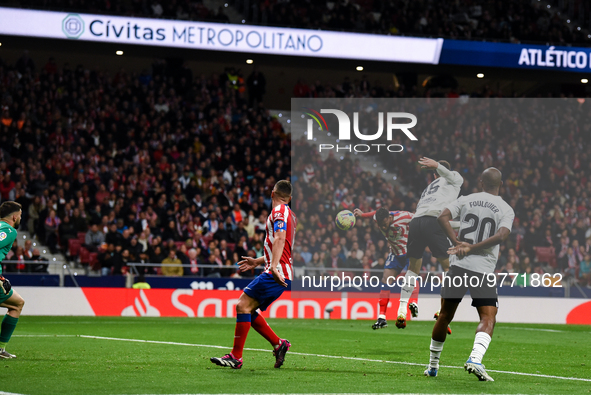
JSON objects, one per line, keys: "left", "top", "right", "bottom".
{"left": 441, "top": 265, "right": 499, "bottom": 307}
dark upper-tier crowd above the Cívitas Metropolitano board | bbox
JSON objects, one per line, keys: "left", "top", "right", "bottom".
{"left": 5, "top": 0, "right": 591, "bottom": 45}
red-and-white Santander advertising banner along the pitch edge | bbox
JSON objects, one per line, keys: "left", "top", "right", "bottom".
{"left": 12, "top": 287, "right": 591, "bottom": 325}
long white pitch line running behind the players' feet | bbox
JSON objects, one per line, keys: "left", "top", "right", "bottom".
{"left": 79, "top": 335, "right": 591, "bottom": 382}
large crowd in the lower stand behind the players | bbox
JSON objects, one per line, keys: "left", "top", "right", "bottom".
{"left": 0, "top": 54, "right": 591, "bottom": 284}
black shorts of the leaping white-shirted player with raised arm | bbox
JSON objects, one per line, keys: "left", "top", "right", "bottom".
{"left": 408, "top": 217, "right": 451, "bottom": 259}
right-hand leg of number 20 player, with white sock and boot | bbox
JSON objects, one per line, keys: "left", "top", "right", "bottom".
{"left": 464, "top": 306, "right": 498, "bottom": 381}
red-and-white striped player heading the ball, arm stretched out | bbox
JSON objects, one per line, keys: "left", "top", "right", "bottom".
{"left": 353, "top": 207, "right": 419, "bottom": 329}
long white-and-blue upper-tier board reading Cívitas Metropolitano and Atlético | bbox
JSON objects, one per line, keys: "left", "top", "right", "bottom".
{"left": 0, "top": 7, "right": 591, "bottom": 72}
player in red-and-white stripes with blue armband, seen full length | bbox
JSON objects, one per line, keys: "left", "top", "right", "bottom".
{"left": 210, "top": 180, "right": 297, "bottom": 369}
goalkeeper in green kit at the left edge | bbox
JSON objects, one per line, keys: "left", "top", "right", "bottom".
{"left": 0, "top": 202, "right": 25, "bottom": 358}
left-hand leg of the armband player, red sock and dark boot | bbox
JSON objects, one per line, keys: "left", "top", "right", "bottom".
{"left": 210, "top": 293, "right": 259, "bottom": 369}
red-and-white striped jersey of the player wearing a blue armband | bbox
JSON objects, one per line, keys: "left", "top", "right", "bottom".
{"left": 265, "top": 204, "right": 297, "bottom": 280}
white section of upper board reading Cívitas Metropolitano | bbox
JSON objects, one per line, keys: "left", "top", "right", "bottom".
{"left": 0, "top": 7, "right": 443, "bottom": 64}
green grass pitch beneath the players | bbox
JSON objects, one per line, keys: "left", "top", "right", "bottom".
{"left": 0, "top": 316, "right": 591, "bottom": 395}
